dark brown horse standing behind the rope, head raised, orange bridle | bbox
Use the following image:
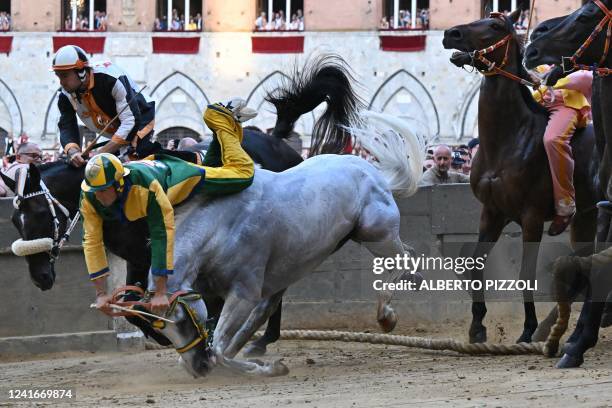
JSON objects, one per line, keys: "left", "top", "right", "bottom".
{"left": 444, "top": 10, "right": 601, "bottom": 342}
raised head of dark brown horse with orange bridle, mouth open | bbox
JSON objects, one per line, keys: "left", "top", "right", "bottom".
{"left": 442, "top": 10, "right": 521, "bottom": 71}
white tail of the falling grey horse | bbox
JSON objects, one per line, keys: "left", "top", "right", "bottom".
{"left": 347, "top": 111, "right": 427, "bottom": 195}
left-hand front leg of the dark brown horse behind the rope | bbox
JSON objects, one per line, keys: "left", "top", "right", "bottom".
{"left": 469, "top": 207, "right": 508, "bottom": 343}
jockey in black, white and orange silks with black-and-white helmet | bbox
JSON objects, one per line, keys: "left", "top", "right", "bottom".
{"left": 52, "top": 45, "right": 158, "bottom": 166}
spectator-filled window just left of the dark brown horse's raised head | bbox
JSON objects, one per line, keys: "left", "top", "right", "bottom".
{"left": 379, "top": 0, "right": 429, "bottom": 30}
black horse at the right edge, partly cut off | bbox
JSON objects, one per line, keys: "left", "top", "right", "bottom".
{"left": 524, "top": 0, "right": 612, "bottom": 368}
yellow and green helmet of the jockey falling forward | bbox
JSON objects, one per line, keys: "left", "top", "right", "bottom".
{"left": 81, "top": 153, "right": 130, "bottom": 192}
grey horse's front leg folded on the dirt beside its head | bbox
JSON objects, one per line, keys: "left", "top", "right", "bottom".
{"left": 213, "top": 292, "right": 288, "bottom": 376}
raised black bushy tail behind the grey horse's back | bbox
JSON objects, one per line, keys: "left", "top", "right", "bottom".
{"left": 266, "top": 55, "right": 365, "bottom": 151}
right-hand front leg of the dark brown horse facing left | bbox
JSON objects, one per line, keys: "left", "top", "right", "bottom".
{"left": 516, "top": 214, "right": 544, "bottom": 343}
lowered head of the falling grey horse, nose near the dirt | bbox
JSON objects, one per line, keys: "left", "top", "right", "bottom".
{"left": 152, "top": 293, "right": 215, "bottom": 377}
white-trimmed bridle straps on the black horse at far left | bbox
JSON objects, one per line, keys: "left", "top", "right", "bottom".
{"left": 13, "top": 172, "right": 80, "bottom": 264}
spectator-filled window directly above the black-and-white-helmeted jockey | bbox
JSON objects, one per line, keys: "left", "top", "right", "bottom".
{"left": 62, "top": 0, "right": 107, "bottom": 31}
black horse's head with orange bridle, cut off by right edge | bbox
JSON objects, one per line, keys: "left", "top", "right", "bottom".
{"left": 523, "top": 0, "right": 612, "bottom": 72}
